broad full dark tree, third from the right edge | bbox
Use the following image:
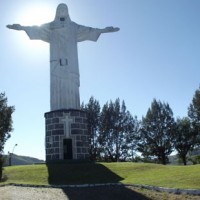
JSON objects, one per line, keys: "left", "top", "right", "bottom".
{"left": 138, "top": 99, "right": 175, "bottom": 165}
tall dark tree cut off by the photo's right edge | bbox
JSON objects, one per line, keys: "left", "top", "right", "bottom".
{"left": 188, "top": 88, "right": 200, "bottom": 144}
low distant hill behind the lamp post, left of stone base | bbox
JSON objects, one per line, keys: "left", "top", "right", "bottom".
{"left": 5, "top": 154, "right": 44, "bottom": 166}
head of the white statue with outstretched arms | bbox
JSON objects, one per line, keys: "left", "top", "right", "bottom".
{"left": 55, "top": 3, "right": 70, "bottom": 21}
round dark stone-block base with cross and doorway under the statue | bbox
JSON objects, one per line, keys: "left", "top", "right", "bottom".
{"left": 44, "top": 109, "right": 89, "bottom": 162}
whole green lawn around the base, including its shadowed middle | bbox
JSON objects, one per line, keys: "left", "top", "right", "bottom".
{"left": 0, "top": 162, "right": 200, "bottom": 189}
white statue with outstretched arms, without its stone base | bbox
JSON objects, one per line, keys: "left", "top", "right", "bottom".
{"left": 7, "top": 4, "right": 119, "bottom": 111}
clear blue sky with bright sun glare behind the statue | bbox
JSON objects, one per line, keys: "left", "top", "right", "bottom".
{"left": 0, "top": 0, "right": 200, "bottom": 159}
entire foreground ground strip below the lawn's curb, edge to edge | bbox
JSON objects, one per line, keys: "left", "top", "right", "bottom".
{"left": 0, "top": 186, "right": 200, "bottom": 200}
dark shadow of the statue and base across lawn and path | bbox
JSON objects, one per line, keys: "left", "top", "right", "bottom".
{"left": 47, "top": 161, "right": 150, "bottom": 200}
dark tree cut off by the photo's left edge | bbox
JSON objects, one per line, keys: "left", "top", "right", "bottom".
{"left": 0, "top": 93, "right": 15, "bottom": 180}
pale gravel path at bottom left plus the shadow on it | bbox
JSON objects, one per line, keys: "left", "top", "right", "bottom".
{"left": 0, "top": 186, "right": 145, "bottom": 200}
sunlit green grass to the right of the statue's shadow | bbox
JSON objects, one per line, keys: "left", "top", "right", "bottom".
{"left": 106, "top": 163, "right": 200, "bottom": 189}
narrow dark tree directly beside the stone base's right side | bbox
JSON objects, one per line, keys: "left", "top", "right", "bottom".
{"left": 82, "top": 97, "right": 100, "bottom": 160}
